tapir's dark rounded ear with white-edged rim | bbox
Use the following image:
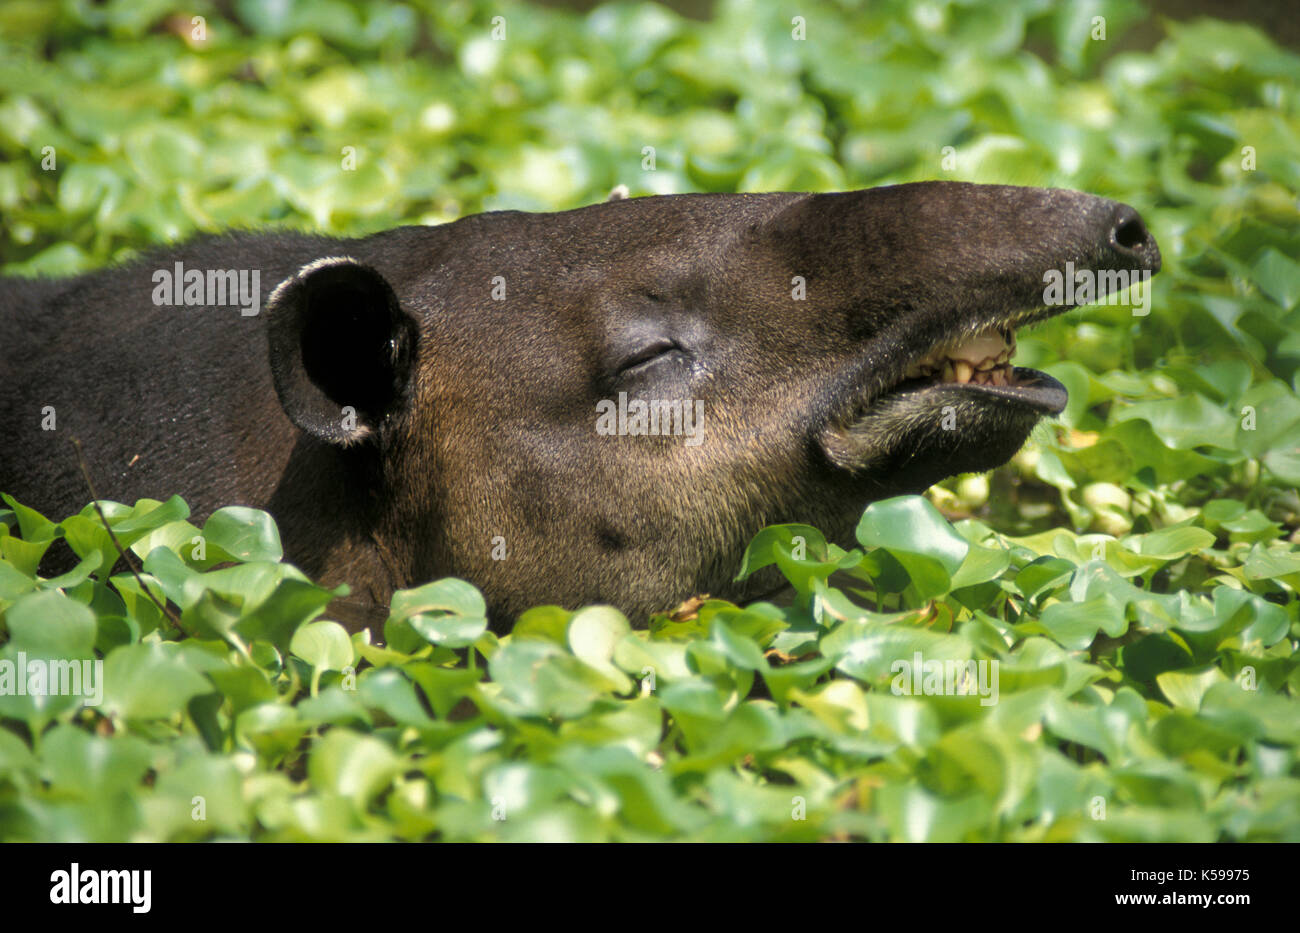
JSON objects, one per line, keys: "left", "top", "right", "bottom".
{"left": 267, "top": 257, "right": 419, "bottom": 444}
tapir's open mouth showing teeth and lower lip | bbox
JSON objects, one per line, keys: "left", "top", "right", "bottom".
{"left": 891, "top": 319, "right": 1070, "bottom": 415}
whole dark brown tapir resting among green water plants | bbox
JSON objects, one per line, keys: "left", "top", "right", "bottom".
{"left": 0, "top": 182, "right": 1161, "bottom": 629}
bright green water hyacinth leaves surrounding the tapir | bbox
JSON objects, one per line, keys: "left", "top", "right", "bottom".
{"left": 0, "top": 0, "right": 1300, "bottom": 841}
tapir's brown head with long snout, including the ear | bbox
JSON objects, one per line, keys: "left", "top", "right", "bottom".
{"left": 268, "top": 182, "right": 1160, "bottom": 624}
